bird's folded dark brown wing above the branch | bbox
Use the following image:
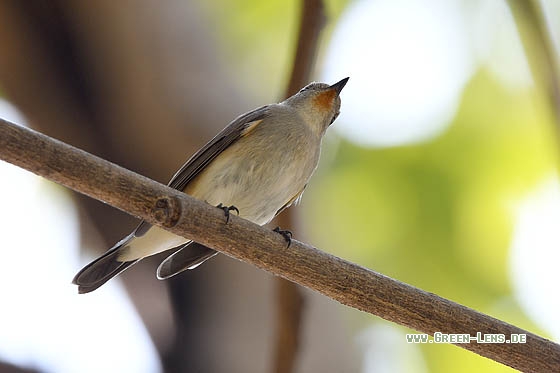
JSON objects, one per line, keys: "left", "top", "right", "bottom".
{"left": 134, "top": 105, "right": 269, "bottom": 237}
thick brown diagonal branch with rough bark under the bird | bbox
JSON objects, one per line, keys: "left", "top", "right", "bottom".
{"left": 0, "top": 119, "right": 560, "bottom": 372}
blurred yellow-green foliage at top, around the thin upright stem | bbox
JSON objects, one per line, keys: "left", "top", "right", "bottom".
{"left": 199, "top": 0, "right": 349, "bottom": 98}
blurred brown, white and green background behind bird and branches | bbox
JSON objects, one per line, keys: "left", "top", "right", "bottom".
{"left": 0, "top": 0, "right": 560, "bottom": 373}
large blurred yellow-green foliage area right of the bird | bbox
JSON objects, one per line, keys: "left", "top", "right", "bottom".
{"left": 304, "top": 71, "right": 556, "bottom": 372}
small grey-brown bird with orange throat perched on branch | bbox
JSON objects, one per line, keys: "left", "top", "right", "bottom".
{"left": 72, "top": 78, "right": 349, "bottom": 294}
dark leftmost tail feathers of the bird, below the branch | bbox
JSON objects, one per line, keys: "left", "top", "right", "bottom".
{"left": 72, "top": 234, "right": 140, "bottom": 294}
